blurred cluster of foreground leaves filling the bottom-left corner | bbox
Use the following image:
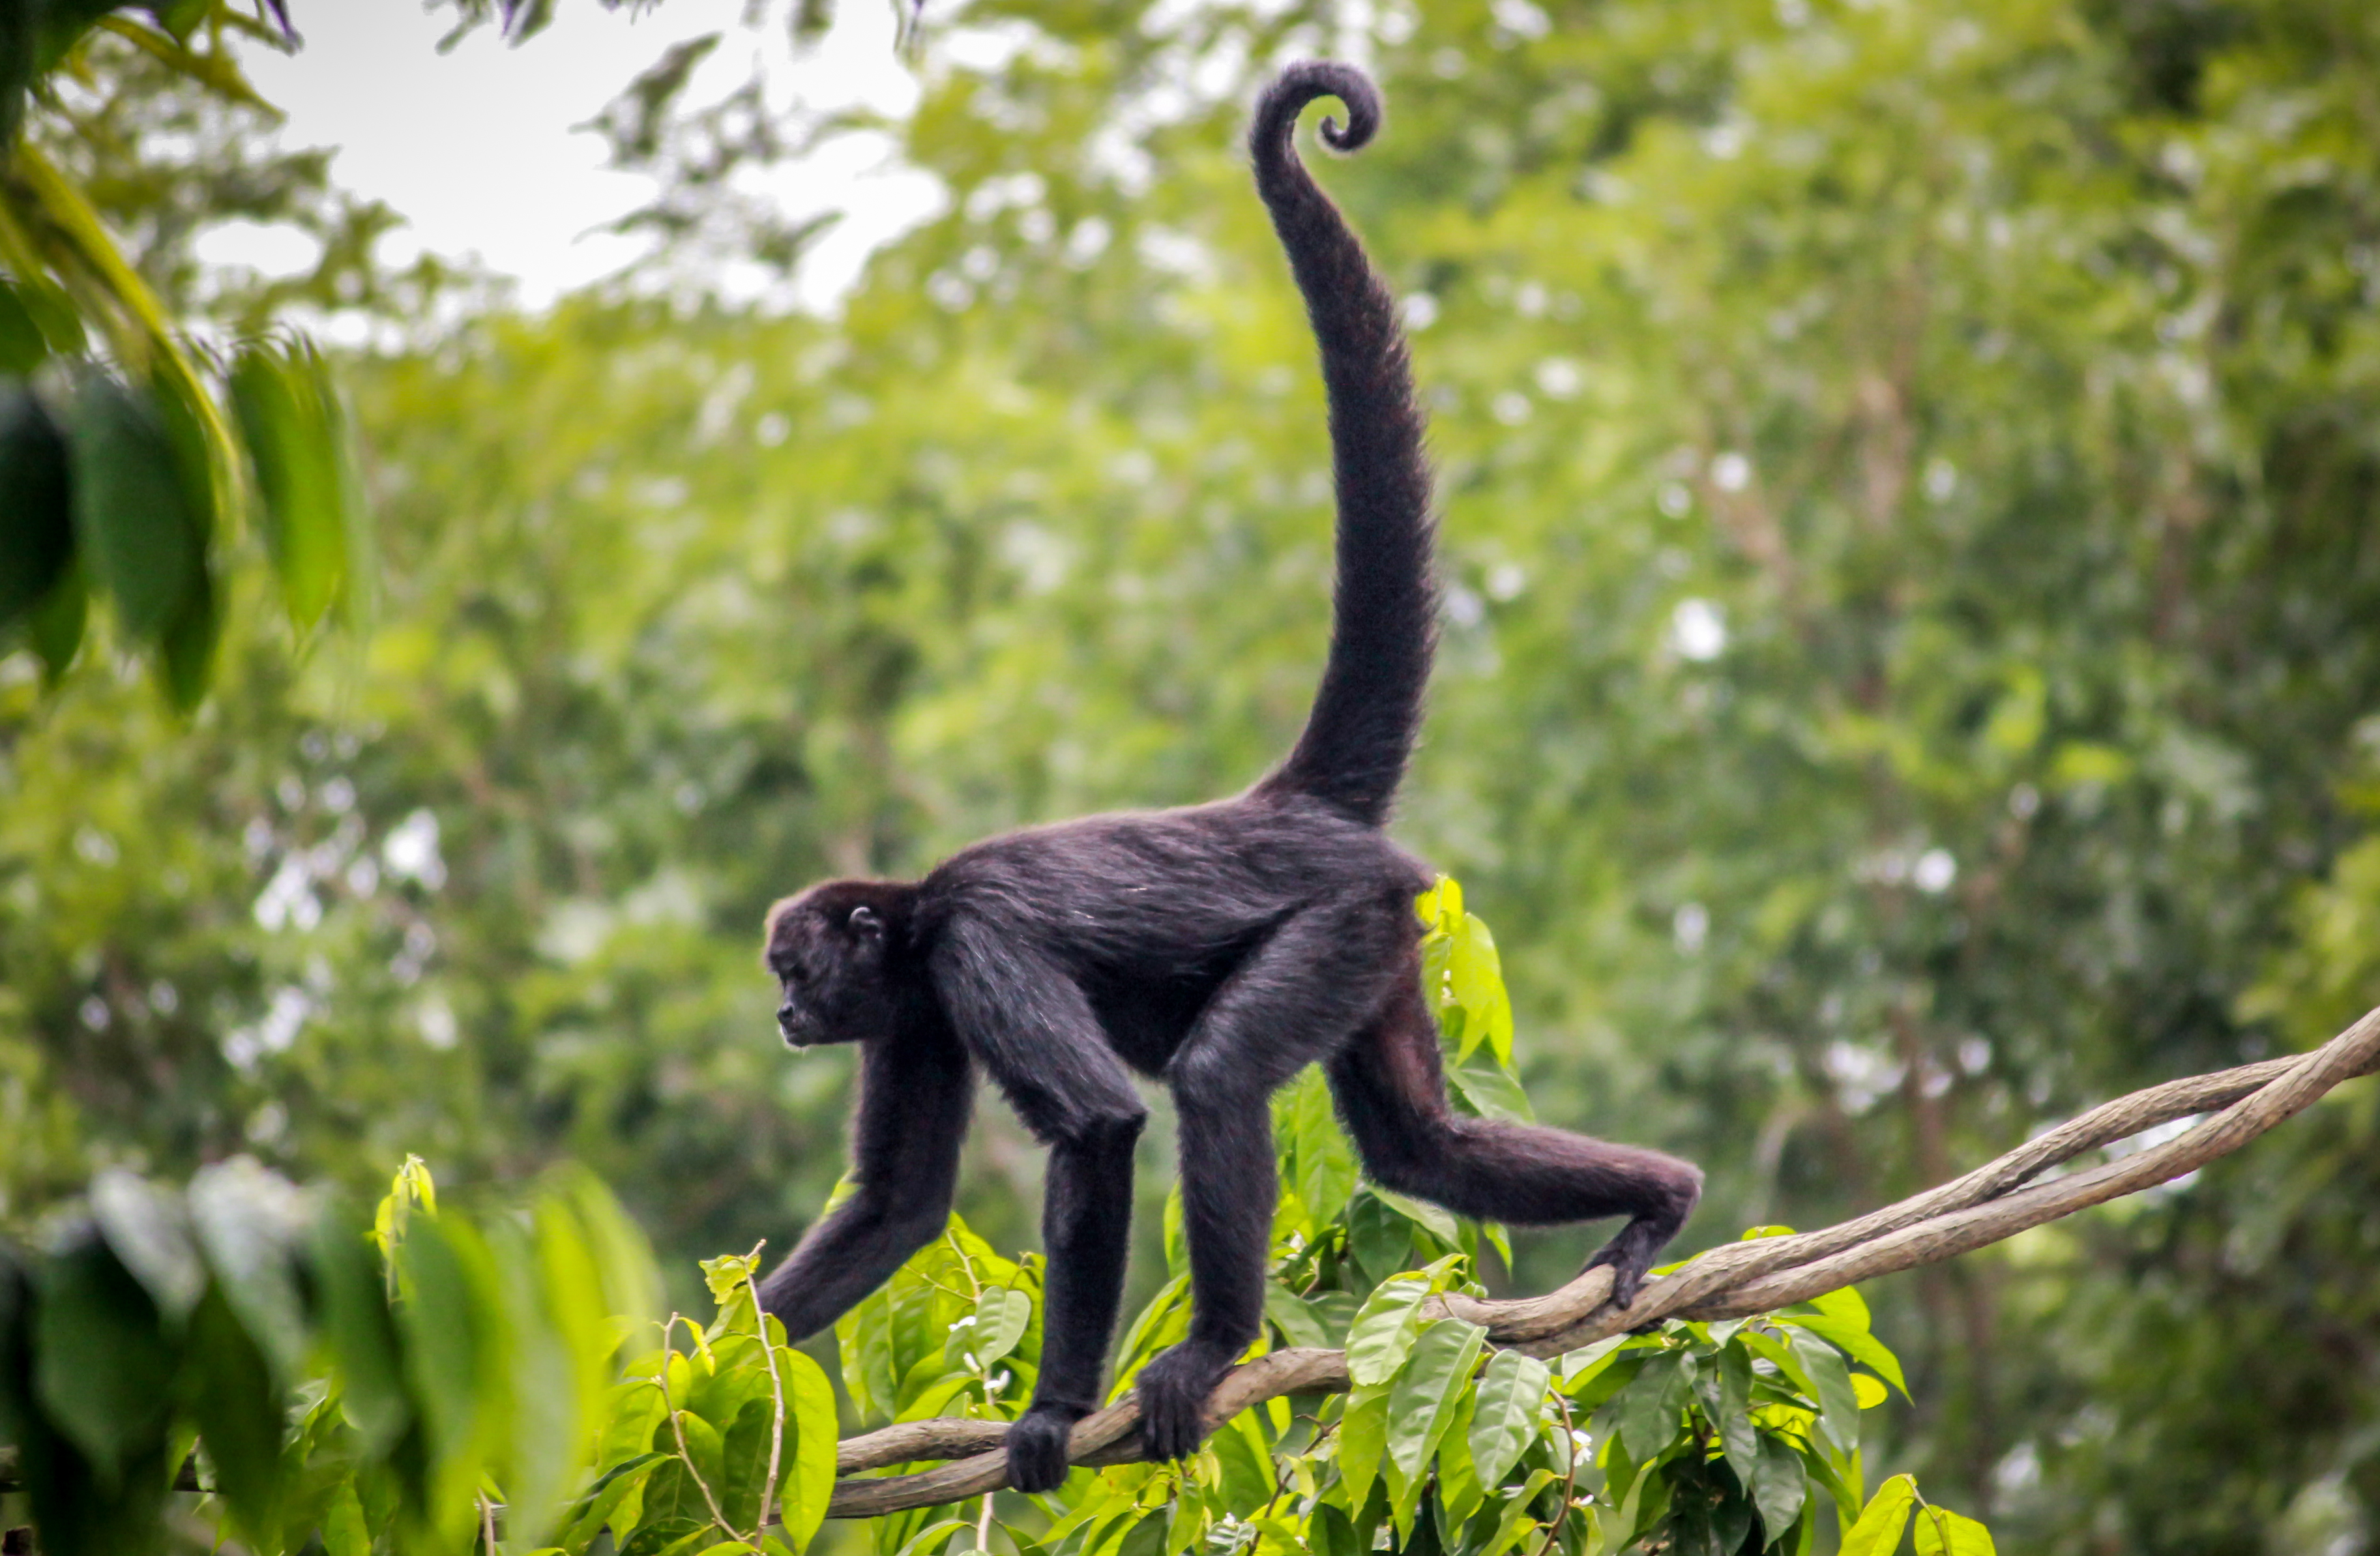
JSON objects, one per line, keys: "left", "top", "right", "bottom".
{"left": 0, "top": 1158, "right": 661, "bottom": 1556}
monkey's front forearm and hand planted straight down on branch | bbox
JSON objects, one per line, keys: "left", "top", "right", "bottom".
{"left": 1006, "top": 1116, "right": 1142, "bottom": 1491}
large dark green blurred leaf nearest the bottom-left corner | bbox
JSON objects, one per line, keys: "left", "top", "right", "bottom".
{"left": 33, "top": 1233, "right": 174, "bottom": 1490}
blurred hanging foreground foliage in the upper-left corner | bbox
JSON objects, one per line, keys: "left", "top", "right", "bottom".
{"left": 0, "top": 0, "right": 364, "bottom": 711}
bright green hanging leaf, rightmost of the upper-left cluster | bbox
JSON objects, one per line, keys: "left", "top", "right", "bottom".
{"left": 231, "top": 343, "right": 357, "bottom": 632}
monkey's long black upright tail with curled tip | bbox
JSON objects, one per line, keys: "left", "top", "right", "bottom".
{"left": 1247, "top": 62, "right": 1437, "bottom": 825}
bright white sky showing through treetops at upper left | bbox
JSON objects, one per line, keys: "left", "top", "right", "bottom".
{"left": 200, "top": 0, "right": 940, "bottom": 307}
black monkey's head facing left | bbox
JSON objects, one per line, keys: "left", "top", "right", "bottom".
{"left": 761, "top": 880, "right": 914, "bottom": 1050}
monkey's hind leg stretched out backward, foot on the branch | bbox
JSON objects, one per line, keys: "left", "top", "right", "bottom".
{"left": 1328, "top": 978, "right": 1701, "bottom": 1308}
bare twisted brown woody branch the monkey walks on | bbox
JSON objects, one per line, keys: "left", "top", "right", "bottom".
{"left": 826, "top": 1009, "right": 2380, "bottom": 1518}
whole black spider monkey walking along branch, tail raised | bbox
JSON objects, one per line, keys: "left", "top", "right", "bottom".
{"left": 761, "top": 62, "right": 1701, "bottom": 1491}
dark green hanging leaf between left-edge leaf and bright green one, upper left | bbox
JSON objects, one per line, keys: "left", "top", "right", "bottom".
{"left": 69, "top": 374, "right": 205, "bottom": 642}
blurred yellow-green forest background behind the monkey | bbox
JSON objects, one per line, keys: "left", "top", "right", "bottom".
{"left": 0, "top": 0, "right": 2380, "bottom": 1553}
